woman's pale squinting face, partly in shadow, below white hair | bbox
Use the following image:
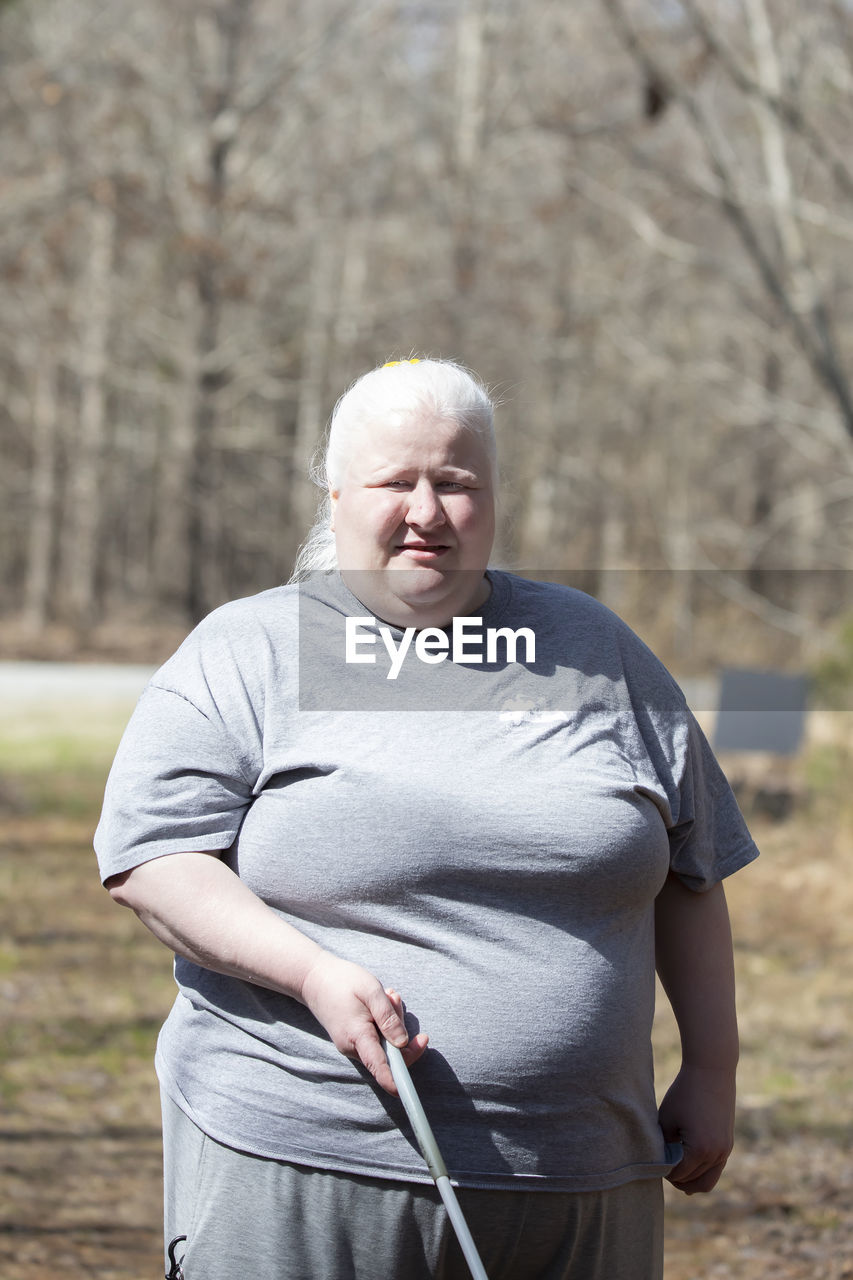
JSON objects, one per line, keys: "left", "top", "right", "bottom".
{"left": 332, "top": 415, "right": 494, "bottom": 627}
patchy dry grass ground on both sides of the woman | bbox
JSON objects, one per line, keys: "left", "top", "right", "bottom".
{"left": 0, "top": 709, "right": 853, "bottom": 1280}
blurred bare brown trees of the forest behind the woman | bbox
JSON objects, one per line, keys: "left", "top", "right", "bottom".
{"left": 0, "top": 0, "right": 853, "bottom": 666}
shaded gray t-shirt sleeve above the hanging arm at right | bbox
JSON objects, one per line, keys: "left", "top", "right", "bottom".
{"left": 669, "top": 712, "right": 758, "bottom": 892}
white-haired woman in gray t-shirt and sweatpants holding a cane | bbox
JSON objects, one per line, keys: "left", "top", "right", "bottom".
{"left": 96, "top": 360, "right": 756, "bottom": 1280}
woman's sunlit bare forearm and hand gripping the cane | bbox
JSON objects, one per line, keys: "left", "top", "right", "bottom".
{"left": 106, "top": 852, "right": 427, "bottom": 1093}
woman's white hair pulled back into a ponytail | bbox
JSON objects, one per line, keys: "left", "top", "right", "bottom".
{"left": 291, "top": 360, "right": 497, "bottom": 582}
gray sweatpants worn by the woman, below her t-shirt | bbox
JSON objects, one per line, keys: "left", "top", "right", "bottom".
{"left": 163, "top": 1097, "right": 663, "bottom": 1280}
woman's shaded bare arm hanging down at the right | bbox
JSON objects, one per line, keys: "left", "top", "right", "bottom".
{"left": 654, "top": 873, "right": 738, "bottom": 1196}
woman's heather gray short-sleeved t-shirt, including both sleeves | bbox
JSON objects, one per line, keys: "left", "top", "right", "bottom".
{"left": 96, "top": 571, "right": 757, "bottom": 1190}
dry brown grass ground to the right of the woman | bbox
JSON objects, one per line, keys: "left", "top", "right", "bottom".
{"left": 656, "top": 724, "right": 853, "bottom": 1280}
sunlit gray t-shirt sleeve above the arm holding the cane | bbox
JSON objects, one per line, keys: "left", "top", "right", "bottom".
{"left": 95, "top": 685, "right": 252, "bottom": 881}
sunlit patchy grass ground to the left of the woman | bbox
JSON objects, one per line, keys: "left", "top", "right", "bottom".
{"left": 0, "top": 705, "right": 173, "bottom": 1280}
